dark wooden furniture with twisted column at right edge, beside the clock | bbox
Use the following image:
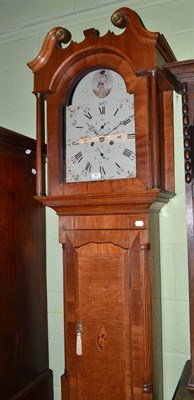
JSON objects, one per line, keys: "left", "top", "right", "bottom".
{"left": 165, "top": 59, "right": 194, "bottom": 400}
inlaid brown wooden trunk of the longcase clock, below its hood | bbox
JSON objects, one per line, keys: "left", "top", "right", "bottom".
{"left": 61, "top": 216, "right": 152, "bottom": 400}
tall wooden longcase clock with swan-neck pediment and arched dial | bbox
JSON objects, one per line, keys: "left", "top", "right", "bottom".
{"left": 28, "top": 8, "right": 175, "bottom": 400}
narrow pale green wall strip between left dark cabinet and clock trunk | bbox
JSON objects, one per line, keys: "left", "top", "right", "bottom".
{"left": 46, "top": 209, "right": 65, "bottom": 400}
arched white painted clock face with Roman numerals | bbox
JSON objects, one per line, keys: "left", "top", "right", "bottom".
{"left": 65, "top": 69, "right": 136, "bottom": 183}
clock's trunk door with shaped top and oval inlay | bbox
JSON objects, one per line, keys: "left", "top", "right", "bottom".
{"left": 76, "top": 243, "right": 131, "bottom": 400}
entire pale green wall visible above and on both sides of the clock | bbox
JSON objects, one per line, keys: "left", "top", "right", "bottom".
{"left": 0, "top": 0, "right": 194, "bottom": 400}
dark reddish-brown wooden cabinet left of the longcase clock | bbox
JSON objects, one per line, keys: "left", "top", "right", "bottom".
{"left": 0, "top": 128, "right": 53, "bottom": 400}
